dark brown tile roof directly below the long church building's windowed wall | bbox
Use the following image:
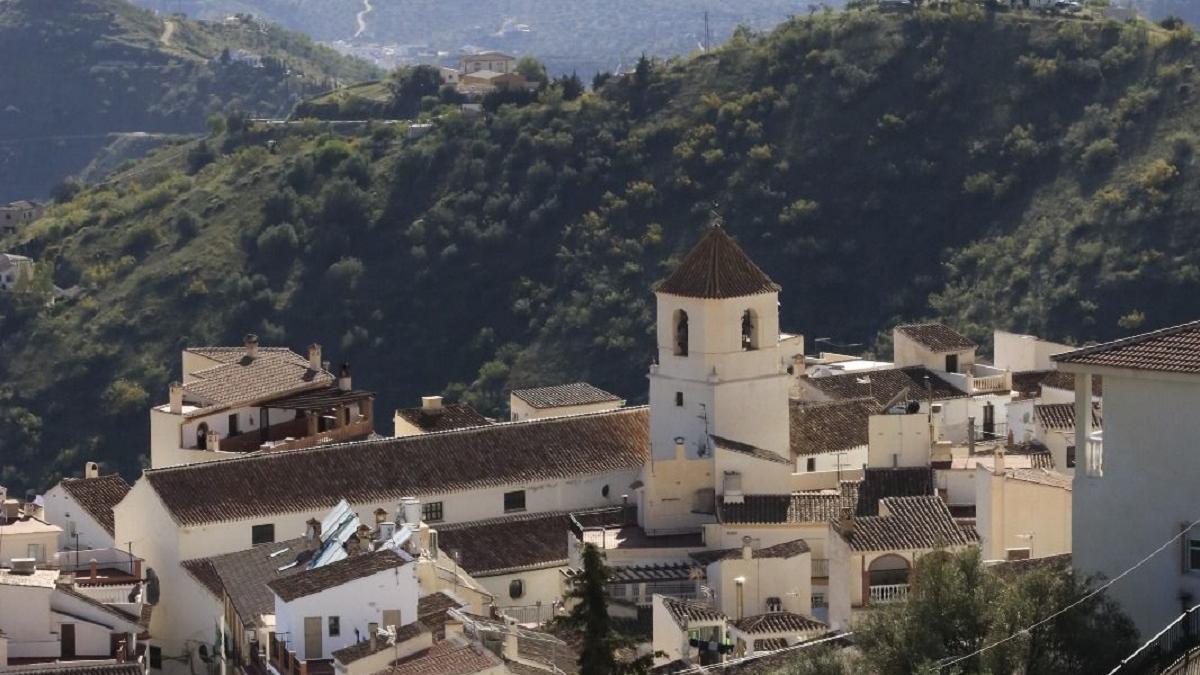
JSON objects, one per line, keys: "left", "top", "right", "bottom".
{"left": 438, "top": 513, "right": 571, "bottom": 577}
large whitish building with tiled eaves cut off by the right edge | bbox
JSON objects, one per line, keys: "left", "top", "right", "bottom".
{"left": 1055, "top": 322, "right": 1200, "bottom": 637}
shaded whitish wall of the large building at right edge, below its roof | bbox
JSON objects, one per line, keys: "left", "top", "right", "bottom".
{"left": 1064, "top": 368, "right": 1200, "bottom": 635}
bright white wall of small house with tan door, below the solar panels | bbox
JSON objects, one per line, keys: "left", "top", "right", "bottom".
{"left": 275, "top": 563, "right": 418, "bottom": 661}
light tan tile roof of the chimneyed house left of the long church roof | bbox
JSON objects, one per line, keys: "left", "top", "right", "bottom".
{"left": 177, "top": 347, "right": 334, "bottom": 407}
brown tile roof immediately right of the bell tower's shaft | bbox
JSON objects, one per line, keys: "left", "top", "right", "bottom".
{"left": 791, "top": 396, "right": 880, "bottom": 456}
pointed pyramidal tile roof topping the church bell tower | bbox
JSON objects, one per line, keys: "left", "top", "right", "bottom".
{"left": 654, "top": 227, "right": 779, "bottom": 298}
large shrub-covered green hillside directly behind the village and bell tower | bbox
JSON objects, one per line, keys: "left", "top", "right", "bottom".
{"left": 0, "top": 4, "right": 1200, "bottom": 485}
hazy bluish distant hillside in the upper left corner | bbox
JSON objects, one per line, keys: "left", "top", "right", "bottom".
{"left": 0, "top": 0, "right": 377, "bottom": 202}
